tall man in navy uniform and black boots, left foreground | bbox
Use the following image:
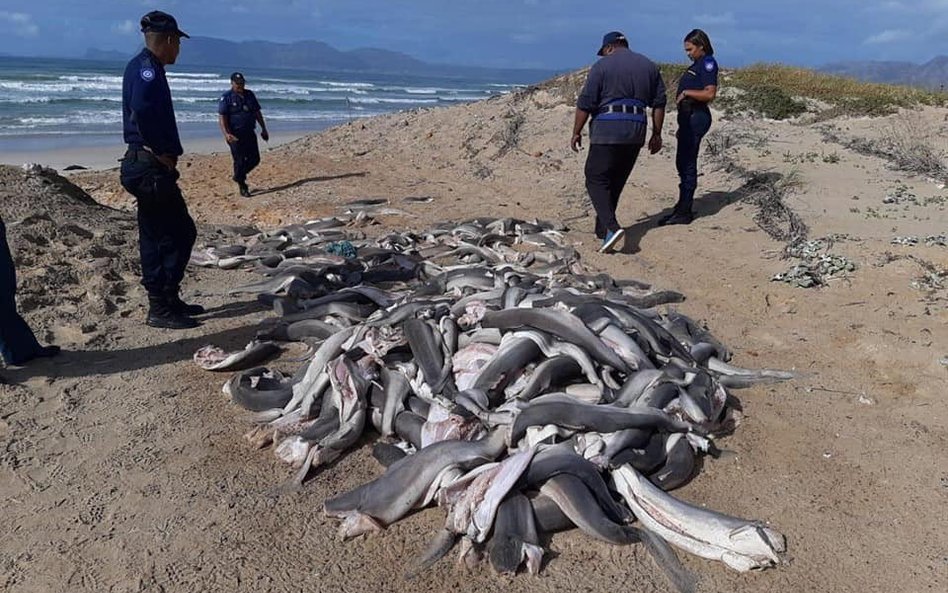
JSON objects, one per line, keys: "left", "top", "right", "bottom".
{"left": 121, "top": 10, "right": 204, "bottom": 329}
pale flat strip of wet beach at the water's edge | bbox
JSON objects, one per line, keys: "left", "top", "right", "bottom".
{"left": 0, "top": 130, "right": 318, "bottom": 174}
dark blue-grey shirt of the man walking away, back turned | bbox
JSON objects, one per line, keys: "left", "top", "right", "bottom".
{"left": 576, "top": 47, "right": 667, "bottom": 144}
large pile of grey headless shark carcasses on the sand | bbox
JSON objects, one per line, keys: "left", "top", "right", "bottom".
{"left": 192, "top": 211, "right": 794, "bottom": 591}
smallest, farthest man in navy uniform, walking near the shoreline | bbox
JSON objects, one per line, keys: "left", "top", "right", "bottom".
{"left": 217, "top": 72, "right": 270, "bottom": 198}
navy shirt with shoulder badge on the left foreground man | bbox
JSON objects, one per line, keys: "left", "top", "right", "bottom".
{"left": 122, "top": 48, "right": 184, "bottom": 156}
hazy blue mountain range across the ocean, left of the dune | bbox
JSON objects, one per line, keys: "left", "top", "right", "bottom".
{"left": 85, "top": 37, "right": 555, "bottom": 81}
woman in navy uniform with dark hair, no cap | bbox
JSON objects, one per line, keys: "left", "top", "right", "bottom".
{"left": 658, "top": 29, "right": 718, "bottom": 226}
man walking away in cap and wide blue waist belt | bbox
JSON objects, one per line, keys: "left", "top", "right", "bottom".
{"left": 570, "top": 31, "right": 666, "bottom": 253}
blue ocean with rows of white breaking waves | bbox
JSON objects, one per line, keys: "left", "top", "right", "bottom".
{"left": 0, "top": 57, "right": 536, "bottom": 152}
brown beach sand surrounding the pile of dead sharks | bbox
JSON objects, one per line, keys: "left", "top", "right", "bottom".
{"left": 0, "top": 75, "right": 948, "bottom": 593}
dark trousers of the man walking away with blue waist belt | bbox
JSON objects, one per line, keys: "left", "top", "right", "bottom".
{"left": 586, "top": 144, "right": 642, "bottom": 239}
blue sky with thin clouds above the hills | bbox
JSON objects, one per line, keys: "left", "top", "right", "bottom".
{"left": 0, "top": 0, "right": 948, "bottom": 70}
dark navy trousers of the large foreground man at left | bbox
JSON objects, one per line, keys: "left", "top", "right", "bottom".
{"left": 121, "top": 150, "right": 197, "bottom": 296}
